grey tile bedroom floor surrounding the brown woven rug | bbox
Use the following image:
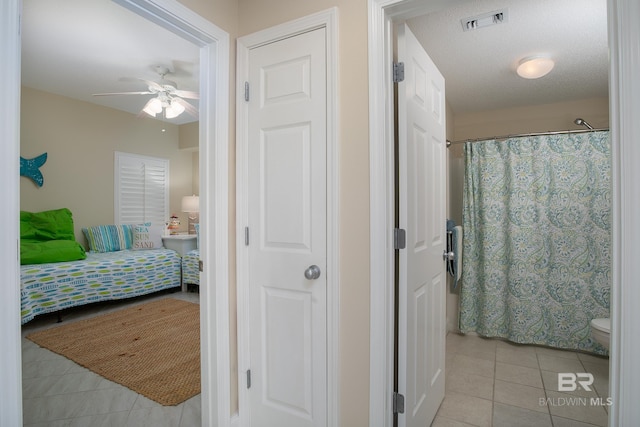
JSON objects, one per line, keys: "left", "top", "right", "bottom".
{"left": 22, "top": 292, "right": 200, "bottom": 427}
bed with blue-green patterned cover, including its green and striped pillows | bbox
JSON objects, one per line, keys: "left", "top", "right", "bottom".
{"left": 20, "top": 208, "right": 181, "bottom": 324}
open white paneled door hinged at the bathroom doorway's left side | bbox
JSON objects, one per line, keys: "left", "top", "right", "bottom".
{"left": 398, "top": 25, "right": 446, "bottom": 427}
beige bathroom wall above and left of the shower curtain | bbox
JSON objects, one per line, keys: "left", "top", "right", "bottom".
{"left": 447, "top": 98, "right": 609, "bottom": 331}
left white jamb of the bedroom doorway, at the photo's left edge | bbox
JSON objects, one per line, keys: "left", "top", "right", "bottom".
{"left": 0, "top": 0, "right": 22, "bottom": 426}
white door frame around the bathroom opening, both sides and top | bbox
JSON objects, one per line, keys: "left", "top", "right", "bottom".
{"left": 368, "top": 0, "right": 640, "bottom": 427}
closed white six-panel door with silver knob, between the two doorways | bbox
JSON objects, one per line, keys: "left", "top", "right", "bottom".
{"left": 247, "top": 29, "right": 327, "bottom": 427}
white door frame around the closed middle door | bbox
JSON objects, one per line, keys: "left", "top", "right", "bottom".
{"left": 236, "top": 8, "right": 340, "bottom": 426}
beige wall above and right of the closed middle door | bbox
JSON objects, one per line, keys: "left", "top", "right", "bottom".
{"left": 239, "top": 0, "right": 370, "bottom": 427}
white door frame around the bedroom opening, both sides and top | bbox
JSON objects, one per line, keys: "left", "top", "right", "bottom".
{"left": 0, "top": 0, "right": 231, "bottom": 426}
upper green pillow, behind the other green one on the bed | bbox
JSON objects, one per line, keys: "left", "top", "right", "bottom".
{"left": 20, "top": 208, "right": 75, "bottom": 241}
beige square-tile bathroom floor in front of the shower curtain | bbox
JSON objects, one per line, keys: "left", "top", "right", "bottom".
{"left": 432, "top": 333, "right": 609, "bottom": 427}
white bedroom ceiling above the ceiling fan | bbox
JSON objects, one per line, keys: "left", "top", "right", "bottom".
{"left": 22, "top": 0, "right": 199, "bottom": 124}
